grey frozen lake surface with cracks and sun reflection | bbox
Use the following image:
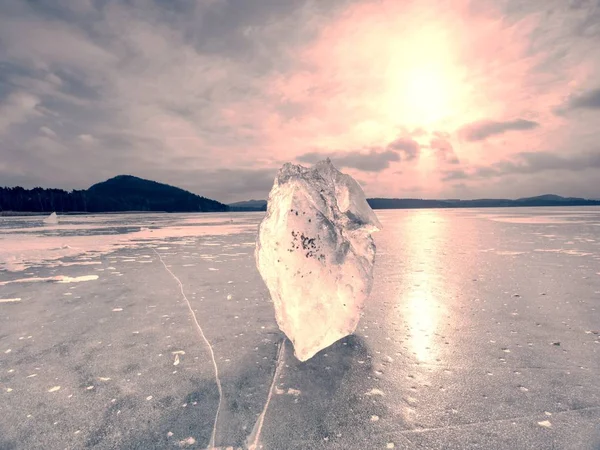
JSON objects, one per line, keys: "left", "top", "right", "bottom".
{"left": 0, "top": 207, "right": 600, "bottom": 450}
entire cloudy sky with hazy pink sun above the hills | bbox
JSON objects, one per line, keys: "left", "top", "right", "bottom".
{"left": 0, "top": 0, "right": 600, "bottom": 202}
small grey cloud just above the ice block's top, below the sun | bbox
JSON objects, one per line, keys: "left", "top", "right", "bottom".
{"left": 297, "top": 149, "right": 400, "bottom": 172}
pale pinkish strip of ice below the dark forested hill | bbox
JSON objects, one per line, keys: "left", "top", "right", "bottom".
{"left": 0, "top": 214, "right": 254, "bottom": 272}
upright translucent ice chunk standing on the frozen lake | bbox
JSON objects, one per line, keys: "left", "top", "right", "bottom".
{"left": 255, "top": 159, "right": 381, "bottom": 361}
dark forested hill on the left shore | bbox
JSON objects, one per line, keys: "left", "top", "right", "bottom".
{"left": 0, "top": 175, "right": 229, "bottom": 213}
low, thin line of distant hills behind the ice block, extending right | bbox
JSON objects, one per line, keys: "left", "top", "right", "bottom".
{"left": 229, "top": 194, "right": 600, "bottom": 211}
